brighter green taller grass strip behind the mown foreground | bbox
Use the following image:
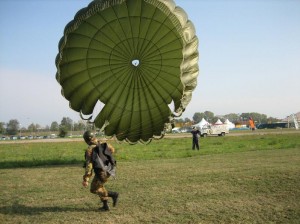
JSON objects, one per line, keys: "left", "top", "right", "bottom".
{"left": 0, "top": 132, "right": 300, "bottom": 168}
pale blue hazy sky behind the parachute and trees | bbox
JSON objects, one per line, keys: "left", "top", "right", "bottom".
{"left": 0, "top": 0, "right": 300, "bottom": 127}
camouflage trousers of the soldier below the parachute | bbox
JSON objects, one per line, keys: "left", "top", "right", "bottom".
{"left": 90, "top": 172, "right": 109, "bottom": 201}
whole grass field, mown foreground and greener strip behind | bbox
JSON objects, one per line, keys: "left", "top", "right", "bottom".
{"left": 0, "top": 132, "right": 300, "bottom": 223}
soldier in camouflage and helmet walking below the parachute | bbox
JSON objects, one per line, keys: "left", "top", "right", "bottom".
{"left": 82, "top": 131, "right": 119, "bottom": 211}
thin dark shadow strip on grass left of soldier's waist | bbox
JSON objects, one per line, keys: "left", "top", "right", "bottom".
{"left": 0, "top": 159, "right": 83, "bottom": 169}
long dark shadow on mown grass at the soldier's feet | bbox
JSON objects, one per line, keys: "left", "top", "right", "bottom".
{"left": 0, "top": 203, "right": 100, "bottom": 215}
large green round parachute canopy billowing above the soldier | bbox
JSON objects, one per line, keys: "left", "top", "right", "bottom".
{"left": 56, "top": 0, "right": 198, "bottom": 143}
